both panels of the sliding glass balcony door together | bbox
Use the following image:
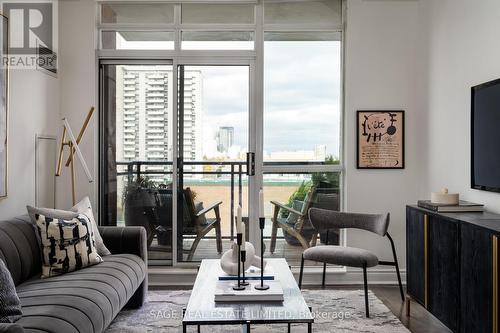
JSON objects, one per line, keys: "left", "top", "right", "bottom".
{"left": 100, "top": 60, "right": 255, "bottom": 265}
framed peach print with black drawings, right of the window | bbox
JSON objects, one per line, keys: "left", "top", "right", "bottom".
{"left": 356, "top": 110, "right": 405, "bottom": 169}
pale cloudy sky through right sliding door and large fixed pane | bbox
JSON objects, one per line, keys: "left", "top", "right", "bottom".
{"left": 197, "top": 41, "right": 341, "bottom": 160}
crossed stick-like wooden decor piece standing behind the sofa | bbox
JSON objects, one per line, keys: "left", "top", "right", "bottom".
{"left": 56, "top": 107, "right": 94, "bottom": 205}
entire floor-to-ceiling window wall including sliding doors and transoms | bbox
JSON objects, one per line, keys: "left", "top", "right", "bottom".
{"left": 97, "top": 0, "right": 344, "bottom": 265}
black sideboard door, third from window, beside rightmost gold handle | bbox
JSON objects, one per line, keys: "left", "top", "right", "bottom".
{"left": 460, "top": 223, "right": 493, "bottom": 333}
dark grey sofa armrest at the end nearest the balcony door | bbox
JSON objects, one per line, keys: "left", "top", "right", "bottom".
{"left": 99, "top": 226, "right": 148, "bottom": 265}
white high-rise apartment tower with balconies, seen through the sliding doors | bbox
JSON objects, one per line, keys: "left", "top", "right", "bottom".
{"left": 116, "top": 66, "right": 202, "bottom": 182}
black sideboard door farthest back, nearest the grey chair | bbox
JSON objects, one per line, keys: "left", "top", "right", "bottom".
{"left": 406, "top": 207, "right": 425, "bottom": 306}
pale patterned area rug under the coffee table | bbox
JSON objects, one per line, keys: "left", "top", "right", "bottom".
{"left": 106, "top": 290, "right": 409, "bottom": 333}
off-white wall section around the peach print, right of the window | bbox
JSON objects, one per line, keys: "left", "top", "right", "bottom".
{"left": 344, "top": 0, "right": 425, "bottom": 279}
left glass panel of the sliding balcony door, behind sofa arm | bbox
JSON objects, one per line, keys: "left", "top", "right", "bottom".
{"left": 100, "top": 61, "right": 175, "bottom": 265}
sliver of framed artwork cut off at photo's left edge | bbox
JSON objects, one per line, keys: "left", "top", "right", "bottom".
{"left": 0, "top": 14, "right": 9, "bottom": 197}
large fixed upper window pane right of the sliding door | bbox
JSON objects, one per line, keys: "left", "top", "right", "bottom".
{"left": 264, "top": 32, "right": 341, "bottom": 163}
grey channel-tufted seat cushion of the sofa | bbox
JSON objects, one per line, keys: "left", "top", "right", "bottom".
{"left": 17, "top": 254, "right": 146, "bottom": 333}
